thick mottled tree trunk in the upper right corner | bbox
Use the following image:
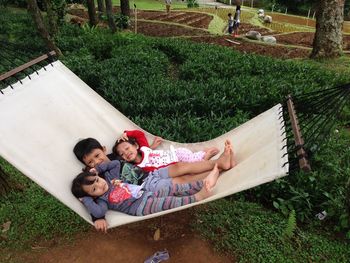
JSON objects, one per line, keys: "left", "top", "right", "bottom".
{"left": 310, "top": 0, "right": 344, "bottom": 58}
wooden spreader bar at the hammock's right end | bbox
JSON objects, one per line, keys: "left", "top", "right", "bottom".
{"left": 287, "top": 95, "right": 311, "bottom": 172}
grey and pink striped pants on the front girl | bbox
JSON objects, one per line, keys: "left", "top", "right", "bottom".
{"left": 136, "top": 181, "right": 203, "bottom": 216}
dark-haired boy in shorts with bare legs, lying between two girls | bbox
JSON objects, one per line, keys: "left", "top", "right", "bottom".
{"left": 73, "top": 138, "right": 234, "bottom": 232}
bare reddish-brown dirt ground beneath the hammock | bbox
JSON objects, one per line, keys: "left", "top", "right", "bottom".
{"left": 8, "top": 208, "right": 235, "bottom": 263}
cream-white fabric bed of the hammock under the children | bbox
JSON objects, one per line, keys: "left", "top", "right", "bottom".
{"left": 0, "top": 61, "right": 289, "bottom": 227}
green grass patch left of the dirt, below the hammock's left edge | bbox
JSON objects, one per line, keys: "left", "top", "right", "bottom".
{"left": 0, "top": 160, "right": 88, "bottom": 251}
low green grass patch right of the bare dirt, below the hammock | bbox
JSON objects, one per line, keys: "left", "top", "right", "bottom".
{"left": 193, "top": 198, "right": 350, "bottom": 263}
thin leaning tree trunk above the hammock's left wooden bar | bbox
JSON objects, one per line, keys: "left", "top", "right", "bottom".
{"left": 27, "top": 0, "right": 62, "bottom": 56}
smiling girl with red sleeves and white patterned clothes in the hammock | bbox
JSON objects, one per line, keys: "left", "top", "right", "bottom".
{"left": 113, "top": 130, "right": 226, "bottom": 172}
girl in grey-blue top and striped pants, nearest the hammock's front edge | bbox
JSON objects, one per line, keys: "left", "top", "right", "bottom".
{"left": 71, "top": 160, "right": 219, "bottom": 217}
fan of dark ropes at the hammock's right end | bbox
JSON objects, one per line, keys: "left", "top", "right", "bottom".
{"left": 283, "top": 84, "right": 350, "bottom": 171}
